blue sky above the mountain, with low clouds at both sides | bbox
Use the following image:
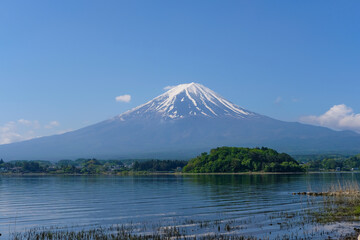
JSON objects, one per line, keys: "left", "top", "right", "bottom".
{"left": 0, "top": 0, "right": 360, "bottom": 144}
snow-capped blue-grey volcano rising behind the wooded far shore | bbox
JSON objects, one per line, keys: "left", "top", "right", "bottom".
{"left": 0, "top": 83, "right": 360, "bottom": 160}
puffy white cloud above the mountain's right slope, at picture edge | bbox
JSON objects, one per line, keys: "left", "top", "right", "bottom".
{"left": 300, "top": 104, "right": 360, "bottom": 133}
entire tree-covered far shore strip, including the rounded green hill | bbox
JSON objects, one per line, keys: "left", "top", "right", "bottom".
{"left": 0, "top": 147, "right": 360, "bottom": 175}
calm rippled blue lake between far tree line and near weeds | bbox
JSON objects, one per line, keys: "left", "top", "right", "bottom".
{"left": 0, "top": 173, "right": 360, "bottom": 239}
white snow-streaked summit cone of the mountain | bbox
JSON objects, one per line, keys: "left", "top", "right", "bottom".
{"left": 118, "top": 82, "right": 256, "bottom": 120}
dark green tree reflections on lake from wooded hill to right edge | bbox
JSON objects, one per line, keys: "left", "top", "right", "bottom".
{"left": 184, "top": 173, "right": 360, "bottom": 200}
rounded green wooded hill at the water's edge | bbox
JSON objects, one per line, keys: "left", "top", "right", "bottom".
{"left": 183, "top": 147, "right": 305, "bottom": 173}
